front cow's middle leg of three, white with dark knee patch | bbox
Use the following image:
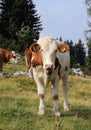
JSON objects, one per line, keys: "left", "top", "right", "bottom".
{"left": 52, "top": 78, "right": 60, "bottom": 116}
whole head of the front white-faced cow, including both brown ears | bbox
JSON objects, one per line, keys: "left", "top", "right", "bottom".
{"left": 31, "top": 37, "right": 69, "bottom": 75}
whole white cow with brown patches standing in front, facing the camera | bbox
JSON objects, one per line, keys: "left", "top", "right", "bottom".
{"left": 31, "top": 36, "right": 70, "bottom": 116}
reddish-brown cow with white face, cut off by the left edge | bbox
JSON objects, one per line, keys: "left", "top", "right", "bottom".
{"left": 0, "top": 48, "right": 17, "bottom": 76}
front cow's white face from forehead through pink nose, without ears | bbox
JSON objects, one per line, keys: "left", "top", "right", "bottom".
{"left": 39, "top": 39, "right": 57, "bottom": 70}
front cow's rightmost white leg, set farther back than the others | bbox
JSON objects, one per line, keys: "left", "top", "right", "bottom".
{"left": 62, "top": 76, "right": 69, "bottom": 112}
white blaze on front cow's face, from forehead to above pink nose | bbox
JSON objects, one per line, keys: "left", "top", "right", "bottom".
{"left": 37, "top": 37, "right": 57, "bottom": 68}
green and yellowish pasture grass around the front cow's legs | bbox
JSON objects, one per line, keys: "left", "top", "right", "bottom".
{"left": 0, "top": 61, "right": 91, "bottom": 130}
